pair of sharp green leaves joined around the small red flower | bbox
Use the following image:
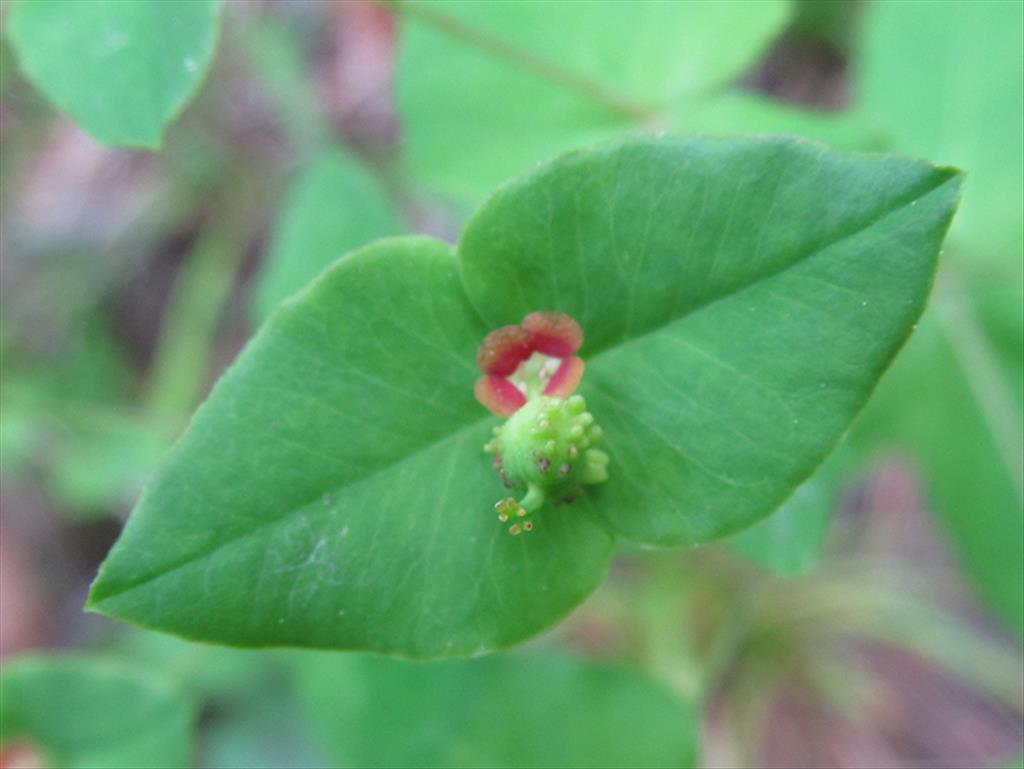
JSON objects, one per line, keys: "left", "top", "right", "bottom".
{"left": 91, "top": 139, "right": 958, "bottom": 656}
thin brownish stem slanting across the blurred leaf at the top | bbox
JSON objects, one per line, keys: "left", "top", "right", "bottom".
{"left": 382, "top": 0, "right": 655, "bottom": 124}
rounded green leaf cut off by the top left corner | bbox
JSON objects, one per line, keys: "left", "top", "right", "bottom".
{"left": 7, "top": 0, "right": 220, "bottom": 148}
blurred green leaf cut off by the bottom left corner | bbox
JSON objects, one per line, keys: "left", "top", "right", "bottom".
{"left": 0, "top": 657, "right": 195, "bottom": 769}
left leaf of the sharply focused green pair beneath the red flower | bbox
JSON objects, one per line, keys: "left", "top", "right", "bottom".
{"left": 91, "top": 238, "right": 611, "bottom": 656}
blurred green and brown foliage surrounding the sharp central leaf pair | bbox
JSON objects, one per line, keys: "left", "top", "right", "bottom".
{"left": 0, "top": 0, "right": 1024, "bottom": 767}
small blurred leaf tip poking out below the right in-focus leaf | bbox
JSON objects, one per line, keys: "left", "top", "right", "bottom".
{"left": 728, "top": 447, "right": 848, "bottom": 576}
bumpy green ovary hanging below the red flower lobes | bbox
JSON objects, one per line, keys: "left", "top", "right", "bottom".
{"left": 484, "top": 395, "right": 608, "bottom": 533}
